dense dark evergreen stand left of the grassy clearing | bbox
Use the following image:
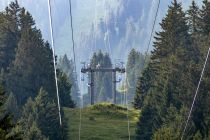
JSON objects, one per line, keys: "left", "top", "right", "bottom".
{"left": 0, "top": 1, "right": 75, "bottom": 140}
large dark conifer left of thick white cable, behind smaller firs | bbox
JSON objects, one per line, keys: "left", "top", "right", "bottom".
{"left": 6, "top": 8, "right": 56, "bottom": 105}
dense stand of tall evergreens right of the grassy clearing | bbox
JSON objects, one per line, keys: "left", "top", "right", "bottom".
{"left": 134, "top": 0, "right": 210, "bottom": 140}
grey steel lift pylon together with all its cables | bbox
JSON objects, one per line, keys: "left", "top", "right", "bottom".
{"left": 48, "top": 0, "right": 210, "bottom": 140}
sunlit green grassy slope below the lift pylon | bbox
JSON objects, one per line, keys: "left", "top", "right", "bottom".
{"left": 64, "top": 104, "right": 139, "bottom": 140}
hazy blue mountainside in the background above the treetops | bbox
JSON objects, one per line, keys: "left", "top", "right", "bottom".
{"left": 0, "top": 0, "right": 202, "bottom": 65}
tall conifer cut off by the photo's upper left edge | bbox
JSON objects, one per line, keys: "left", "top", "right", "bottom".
{"left": 0, "top": 0, "right": 21, "bottom": 71}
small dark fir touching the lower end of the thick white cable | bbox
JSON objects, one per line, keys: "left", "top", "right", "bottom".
{"left": 34, "top": 88, "right": 61, "bottom": 140}
